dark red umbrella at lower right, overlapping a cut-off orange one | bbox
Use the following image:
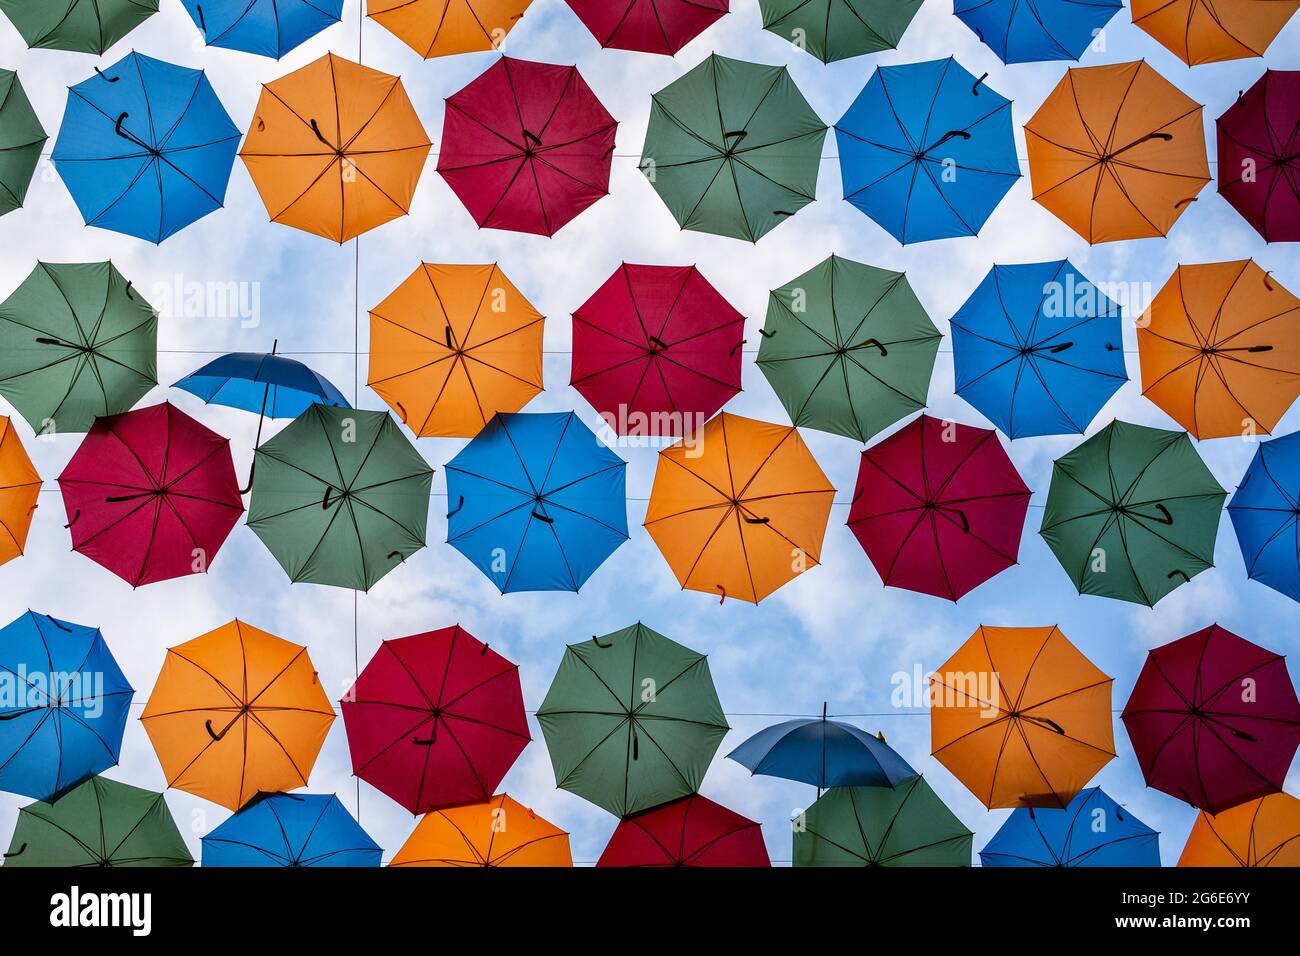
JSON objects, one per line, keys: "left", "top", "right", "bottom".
{"left": 1123, "top": 624, "right": 1300, "bottom": 813}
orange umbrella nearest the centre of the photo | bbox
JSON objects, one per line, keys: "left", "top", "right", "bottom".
{"left": 645, "top": 412, "right": 835, "bottom": 604}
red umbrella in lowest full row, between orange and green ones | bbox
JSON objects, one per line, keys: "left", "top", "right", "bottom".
{"left": 342, "top": 626, "right": 530, "bottom": 813}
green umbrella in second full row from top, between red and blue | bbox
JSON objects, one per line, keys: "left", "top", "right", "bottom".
{"left": 758, "top": 256, "right": 941, "bottom": 442}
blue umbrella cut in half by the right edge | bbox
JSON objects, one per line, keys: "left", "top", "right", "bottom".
{"left": 1227, "top": 432, "right": 1300, "bottom": 601}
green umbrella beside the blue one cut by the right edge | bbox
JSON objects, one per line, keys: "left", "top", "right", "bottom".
{"left": 1040, "top": 421, "right": 1227, "bottom": 607}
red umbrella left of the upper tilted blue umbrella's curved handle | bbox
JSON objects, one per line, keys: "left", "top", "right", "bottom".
{"left": 59, "top": 402, "right": 243, "bottom": 588}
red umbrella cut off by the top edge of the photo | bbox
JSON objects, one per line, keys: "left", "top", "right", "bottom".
{"left": 567, "top": 0, "right": 731, "bottom": 56}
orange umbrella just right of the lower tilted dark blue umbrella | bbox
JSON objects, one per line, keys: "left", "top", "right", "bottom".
{"left": 930, "top": 626, "right": 1115, "bottom": 809}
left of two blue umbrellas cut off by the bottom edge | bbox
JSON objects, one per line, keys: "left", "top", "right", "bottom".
{"left": 203, "top": 793, "right": 382, "bottom": 866}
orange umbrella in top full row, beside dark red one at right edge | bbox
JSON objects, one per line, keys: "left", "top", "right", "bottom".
{"left": 1024, "top": 61, "right": 1209, "bottom": 243}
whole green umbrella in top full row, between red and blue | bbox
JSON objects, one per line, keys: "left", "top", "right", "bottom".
{"left": 641, "top": 53, "right": 826, "bottom": 242}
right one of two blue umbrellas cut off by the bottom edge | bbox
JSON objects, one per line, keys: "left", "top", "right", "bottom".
{"left": 979, "top": 787, "right": 1160, "bottom": 866}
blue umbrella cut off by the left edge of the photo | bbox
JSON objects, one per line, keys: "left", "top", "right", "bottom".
{"left": 0, "top": 611, "right": 135, "bottom": 803}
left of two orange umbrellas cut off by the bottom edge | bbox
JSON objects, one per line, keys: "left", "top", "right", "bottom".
{"left": 390, "top": 793, "right": 573, "bottom": 866}
